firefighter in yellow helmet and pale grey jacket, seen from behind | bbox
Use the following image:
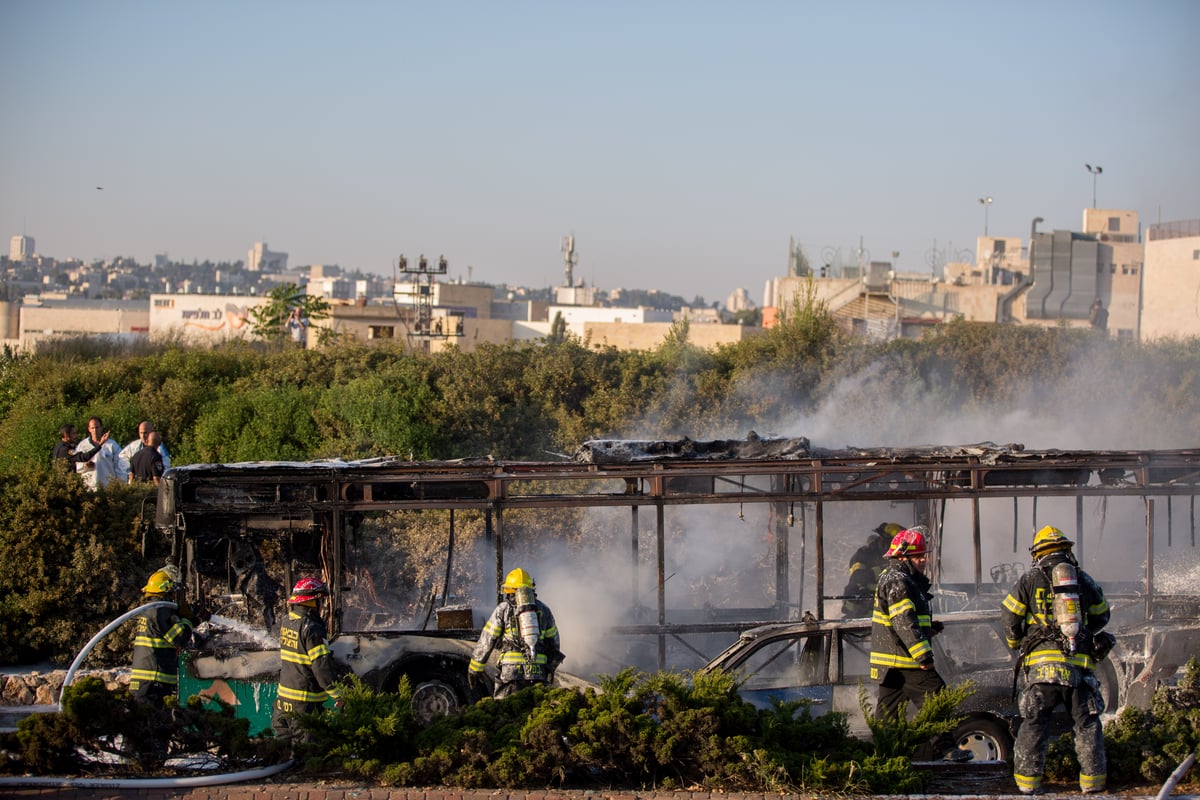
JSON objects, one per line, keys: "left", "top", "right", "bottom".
{"left": 467, "top": 569, "right": 564, "bottom": 699}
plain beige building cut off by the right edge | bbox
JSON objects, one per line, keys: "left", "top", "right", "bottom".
{"left": 1141, "top": 219, "right": 1200, "bottom": 342}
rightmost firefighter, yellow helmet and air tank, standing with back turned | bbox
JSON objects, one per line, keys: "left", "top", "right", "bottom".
{"left": 1001, "top": 525, "right": 1115, "bottom": 794}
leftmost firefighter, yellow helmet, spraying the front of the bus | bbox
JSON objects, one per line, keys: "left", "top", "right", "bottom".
{"left": 130, "top": 565, "right": 206, "bottom": 704}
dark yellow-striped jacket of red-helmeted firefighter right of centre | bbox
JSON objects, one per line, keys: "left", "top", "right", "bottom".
{"left": 871, "top": 559, "right": 934, "bottom": 680}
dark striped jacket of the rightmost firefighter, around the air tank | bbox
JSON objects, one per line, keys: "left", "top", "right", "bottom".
{"left": 1001, "top": 553, "right": 1110, "bottom": 686}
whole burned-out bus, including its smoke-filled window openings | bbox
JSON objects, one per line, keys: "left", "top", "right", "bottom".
{"left": 146, "top": 434, "right": 1200, "bottom": 717}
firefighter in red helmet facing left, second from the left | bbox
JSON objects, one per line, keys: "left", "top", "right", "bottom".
{"left": 271, "top": 578, "right": 342, "bottom": 744}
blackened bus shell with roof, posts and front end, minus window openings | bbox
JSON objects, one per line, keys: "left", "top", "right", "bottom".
{"left": 155, "top": 434, "right": 1200, "bottom": 729}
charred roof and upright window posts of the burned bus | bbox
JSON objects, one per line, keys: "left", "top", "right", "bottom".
{"left": 156, "top": 438, "right": 1200, "bottom": 666}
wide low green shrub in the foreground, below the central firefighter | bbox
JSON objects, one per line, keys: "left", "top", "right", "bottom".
{"left": 306, "top": 669, "right": 920, "bottom": 792}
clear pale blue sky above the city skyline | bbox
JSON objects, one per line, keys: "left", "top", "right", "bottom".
{"left": 0, "top": 0, "right": 1200, "bottom": 302}
